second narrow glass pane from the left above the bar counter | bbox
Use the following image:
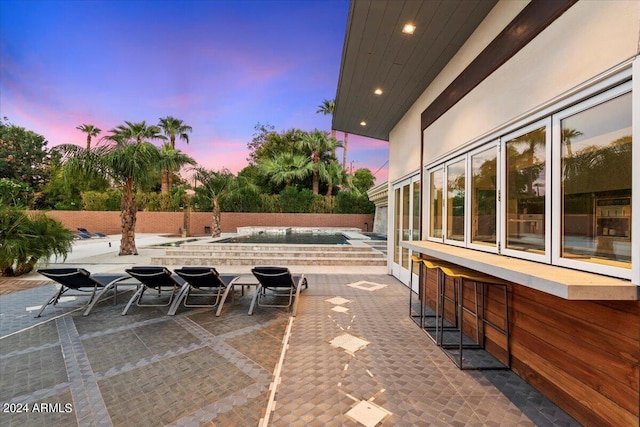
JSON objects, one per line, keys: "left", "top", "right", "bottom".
{"left": 445, "top": 159, "right": 466, "bottom": 242}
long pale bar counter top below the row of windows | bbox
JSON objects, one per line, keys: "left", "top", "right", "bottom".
{"left": 400, "top": 240, "right": 640, "bottom": 301}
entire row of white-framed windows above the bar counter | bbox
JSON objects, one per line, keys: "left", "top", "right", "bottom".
{"left": 425, "top": 79, "right": 639, "bottom": 279}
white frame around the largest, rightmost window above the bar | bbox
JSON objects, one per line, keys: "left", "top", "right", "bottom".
{"left": 551, "top": 81, "right": 638, "bottom": 279}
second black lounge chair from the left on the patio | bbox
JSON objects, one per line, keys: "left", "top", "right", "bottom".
{"left": 122, "top": 267, "right": 184, "bottom": 316}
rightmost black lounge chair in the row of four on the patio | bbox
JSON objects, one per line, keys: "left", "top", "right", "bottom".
{"left": 249, "top": 267, "right": 309, "bottom": 317}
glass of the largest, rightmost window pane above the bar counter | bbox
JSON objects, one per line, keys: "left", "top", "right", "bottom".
{"left": 559, "top": 93, "right": 632, "bottom": 268}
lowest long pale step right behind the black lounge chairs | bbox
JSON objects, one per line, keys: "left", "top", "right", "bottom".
{"left": 151, "top": 255, "right": 387, "bottom": 267}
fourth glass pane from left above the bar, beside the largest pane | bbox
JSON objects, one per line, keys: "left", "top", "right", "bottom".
{"left": 506, "top": 126, "right": 546, "bottom": 254}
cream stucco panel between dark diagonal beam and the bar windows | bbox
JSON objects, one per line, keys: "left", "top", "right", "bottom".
{"left": 422, "top": 0, "right": 640, "bottom": 164}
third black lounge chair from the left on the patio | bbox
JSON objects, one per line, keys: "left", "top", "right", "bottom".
{"left": 169, "top": 267, "right": 239, "bottom": 316}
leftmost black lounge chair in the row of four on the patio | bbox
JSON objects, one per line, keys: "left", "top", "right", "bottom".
{"left": 36, "top": 268, "right": 129, "bottom": 317}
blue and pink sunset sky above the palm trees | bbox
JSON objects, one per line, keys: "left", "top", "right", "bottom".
{"left": 0, "top": 0, "right": 388, "bottom": 184}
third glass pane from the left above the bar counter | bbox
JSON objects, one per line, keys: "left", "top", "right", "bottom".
{"left": 470, "top": 143, "right": 498, "bottom": 247}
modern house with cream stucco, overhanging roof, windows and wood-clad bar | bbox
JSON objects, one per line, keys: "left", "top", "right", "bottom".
{"left": 333, "top": 0, "right": 640, "bottom": 426}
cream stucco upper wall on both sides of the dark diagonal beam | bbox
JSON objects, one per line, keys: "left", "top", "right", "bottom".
{"left": 389, "top": 0, "right": 640, "bottom": 175}
